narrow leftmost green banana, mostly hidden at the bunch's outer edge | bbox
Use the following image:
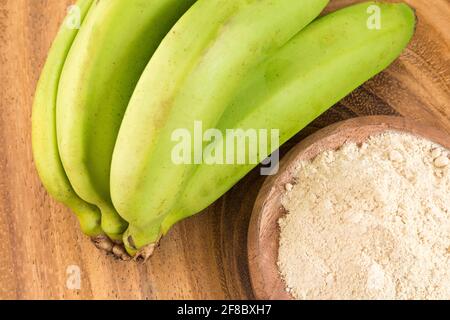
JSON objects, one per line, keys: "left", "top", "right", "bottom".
{"left": 32, "top": 0, "right": 102, "bottom": 237}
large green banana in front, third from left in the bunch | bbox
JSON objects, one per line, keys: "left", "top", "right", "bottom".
{"left": 111, "top": 0, "right": 328, "bottom": 254}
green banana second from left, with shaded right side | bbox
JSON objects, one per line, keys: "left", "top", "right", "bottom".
{"left": 56, "top": 0, "right": 194, "bottom": 241}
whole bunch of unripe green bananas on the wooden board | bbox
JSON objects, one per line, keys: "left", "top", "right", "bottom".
{"left": 32, "top": 0, "right": 415, "bottom": 259}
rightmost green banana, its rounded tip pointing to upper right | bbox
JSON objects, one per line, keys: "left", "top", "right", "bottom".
{"left": 167, "top": 2, "right": 416, "bottom": 232}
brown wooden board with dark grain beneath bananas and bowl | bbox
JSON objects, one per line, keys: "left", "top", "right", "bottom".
{"left": 0, "top": 0, "right": 450, "bottom": 299}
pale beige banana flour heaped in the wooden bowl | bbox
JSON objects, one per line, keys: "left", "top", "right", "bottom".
{"left": 278, "top": 131, "right": 450, "bottom": 299}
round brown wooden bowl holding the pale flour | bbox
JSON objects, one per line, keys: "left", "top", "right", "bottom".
{"left": 248, "top": 116, "right": 450, "bottom": 300}
